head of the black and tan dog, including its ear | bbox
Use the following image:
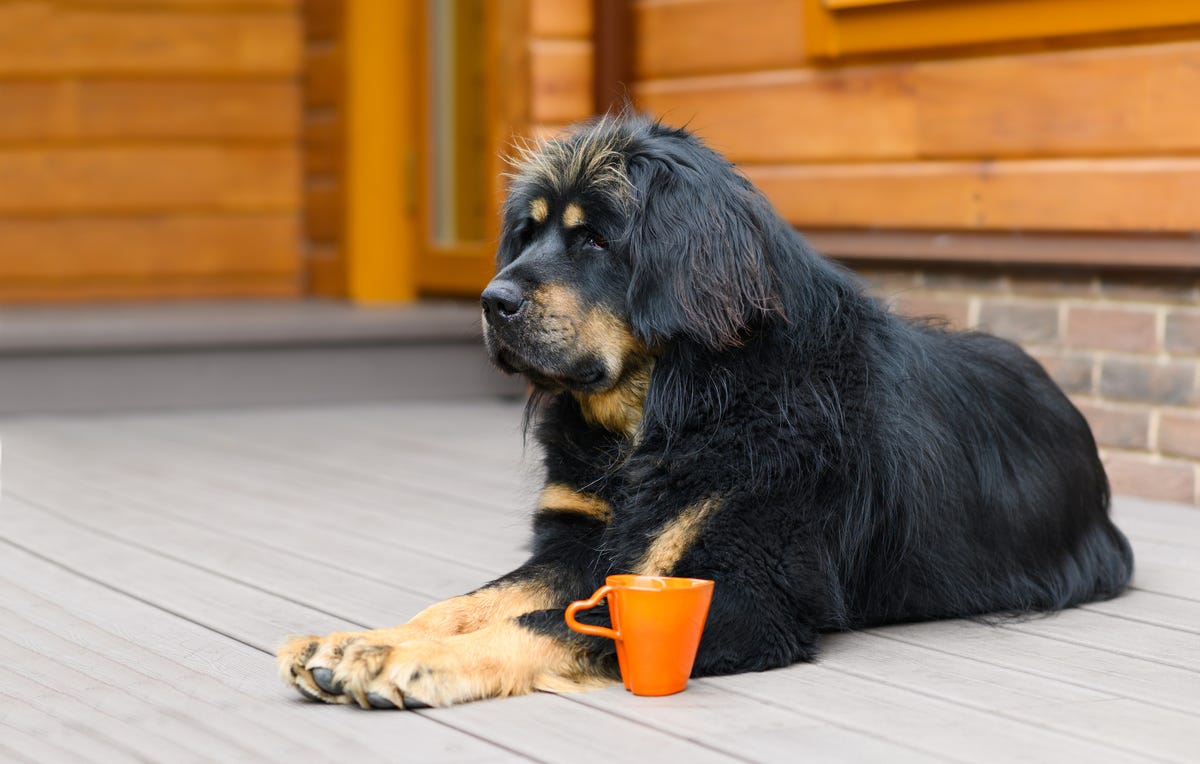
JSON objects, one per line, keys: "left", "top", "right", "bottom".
{"left": 482, "top": 115, "right": 774, "bottom": 393}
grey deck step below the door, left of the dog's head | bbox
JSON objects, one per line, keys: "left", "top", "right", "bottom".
{"left": 0, "top": 300, "right": 522, "bottom": 415}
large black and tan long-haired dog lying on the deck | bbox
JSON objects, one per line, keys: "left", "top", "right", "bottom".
{"left": 278, "top": 116, "right": 1133, "bottom": 708}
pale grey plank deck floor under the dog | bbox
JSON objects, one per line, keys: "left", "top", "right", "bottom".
{"left": 0, "top": 402, "right": 1200, "bottom": 764}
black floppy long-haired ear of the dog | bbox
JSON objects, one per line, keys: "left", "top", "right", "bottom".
{"left": 626, "top": 131, "right": 774, "bottom": 349}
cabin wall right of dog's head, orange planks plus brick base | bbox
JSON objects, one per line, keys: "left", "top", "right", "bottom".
{"left": 632, "top": 0, "right": 1200, "bottom": 504}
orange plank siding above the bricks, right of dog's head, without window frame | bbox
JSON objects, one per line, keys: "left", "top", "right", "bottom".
{"left": 635, "top": 0, "right": 1200, "bottom": 247}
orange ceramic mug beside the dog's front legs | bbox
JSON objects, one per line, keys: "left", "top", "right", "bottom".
{"left": 566, "top": 576, "right": 713, "bottom": 696}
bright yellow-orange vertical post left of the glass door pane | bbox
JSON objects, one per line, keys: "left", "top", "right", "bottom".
{"left": 344, "top": 0, "right": 422, "bottom": 302}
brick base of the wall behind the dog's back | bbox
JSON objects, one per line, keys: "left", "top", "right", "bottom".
{"left": 854, "top": 264, "right": 1200, "bottom": 504}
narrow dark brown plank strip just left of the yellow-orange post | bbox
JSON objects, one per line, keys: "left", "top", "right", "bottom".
{"left": 302, "top": 0, "right": 347, "bottom": 297}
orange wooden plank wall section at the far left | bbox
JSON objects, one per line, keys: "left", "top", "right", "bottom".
{"left": 0, "top": 0, "right": 301, "bottom": 301}
